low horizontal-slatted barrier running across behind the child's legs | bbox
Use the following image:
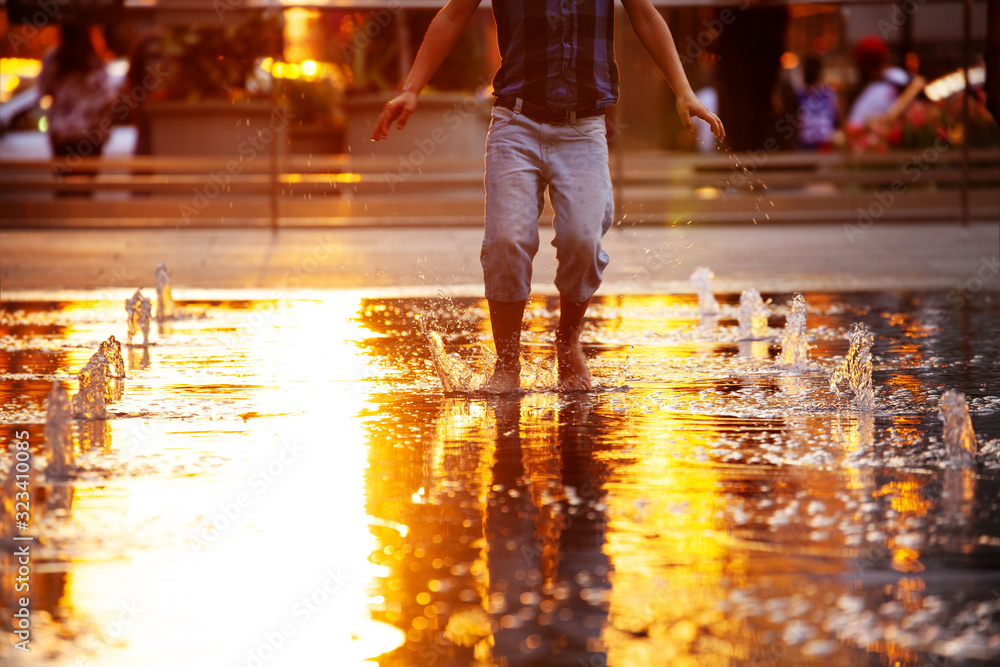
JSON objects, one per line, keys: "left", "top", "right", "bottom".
{"left": 0, "top": 147, "right": 1000, "bottom": 228}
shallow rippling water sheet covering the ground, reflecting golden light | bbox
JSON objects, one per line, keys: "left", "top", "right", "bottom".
{"left": 0, "top": 290, "right": 1000, "bottom": 667}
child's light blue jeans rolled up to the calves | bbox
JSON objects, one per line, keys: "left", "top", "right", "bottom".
{"left": 480, "top": 107, "right": 614, "bottom": 303}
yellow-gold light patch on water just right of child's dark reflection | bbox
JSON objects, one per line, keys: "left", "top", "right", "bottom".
{"left": 603, "top": 416, "right": 732, "bottom": 664}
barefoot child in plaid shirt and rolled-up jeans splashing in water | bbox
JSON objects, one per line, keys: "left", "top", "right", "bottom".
{"left": 372, "top": 0, "right": 725, "bottom": 393}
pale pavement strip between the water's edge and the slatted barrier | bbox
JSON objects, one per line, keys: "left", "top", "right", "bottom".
{"left": 0, "top": 222, "right": 1000, "bottom": 298}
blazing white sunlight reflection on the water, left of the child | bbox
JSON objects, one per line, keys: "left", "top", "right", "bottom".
{"left": 52, "top": 296, "right": 402, "bottom": 666}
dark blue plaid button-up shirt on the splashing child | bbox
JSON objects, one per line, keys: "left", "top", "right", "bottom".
{"left": 492, "top": 0, "right": 618, "bottom": 110}
